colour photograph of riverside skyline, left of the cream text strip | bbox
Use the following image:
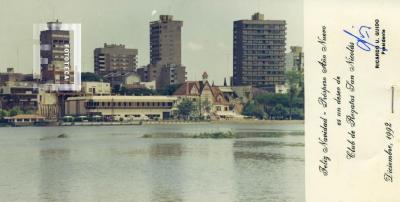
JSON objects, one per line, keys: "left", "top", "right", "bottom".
{"left": 0, "top": 0, "right": 306, "bottom": 202}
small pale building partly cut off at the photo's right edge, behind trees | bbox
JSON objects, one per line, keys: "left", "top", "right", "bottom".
{"left": 285, "top": 46, "right": 304, "bottom": 72}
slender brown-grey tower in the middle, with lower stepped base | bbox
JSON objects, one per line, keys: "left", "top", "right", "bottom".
{"left": 138, "top": 15, "right": 186, "bottom": 88}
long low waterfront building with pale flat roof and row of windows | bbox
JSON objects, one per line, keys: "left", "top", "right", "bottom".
{"left": 65, "top": 95, "right": 176, "bottom": 119}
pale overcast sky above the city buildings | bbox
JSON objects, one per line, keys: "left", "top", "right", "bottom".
{"left": 0, "top": 0, "right": 303, "bottom": 84}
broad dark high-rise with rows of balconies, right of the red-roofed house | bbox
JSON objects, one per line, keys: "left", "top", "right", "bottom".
{"left": 233, "top": 13, "right": 286, "bottom": 90}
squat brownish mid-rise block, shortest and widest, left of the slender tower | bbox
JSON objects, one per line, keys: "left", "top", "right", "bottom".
{"left": 94, "top": 43, "right": 138, "bottom": 75}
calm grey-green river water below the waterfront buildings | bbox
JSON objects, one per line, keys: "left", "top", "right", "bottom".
{"left": 0, "top": 124, "right": 304, "bottom": 202}
